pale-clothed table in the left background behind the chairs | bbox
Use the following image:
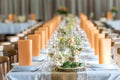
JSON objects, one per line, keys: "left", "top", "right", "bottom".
{"left": 0, "top": 22, "right": 36, "bottom": 34}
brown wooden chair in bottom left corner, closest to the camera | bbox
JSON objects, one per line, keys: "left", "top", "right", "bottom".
{"left": 0, "top": 56, "right": 9, "bottom": 80}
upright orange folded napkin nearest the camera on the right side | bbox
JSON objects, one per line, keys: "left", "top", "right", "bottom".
{"left": 99, "top": 38, "right": 111, "bottom": 64}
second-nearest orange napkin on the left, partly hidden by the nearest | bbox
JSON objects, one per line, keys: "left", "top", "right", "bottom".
{"left": 28, "top": 34, "right": 40, "bottom": 56}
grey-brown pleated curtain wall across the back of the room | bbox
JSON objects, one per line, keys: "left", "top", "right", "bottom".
{"left": 0, "top": 0, "right": 120, "bottom": 20}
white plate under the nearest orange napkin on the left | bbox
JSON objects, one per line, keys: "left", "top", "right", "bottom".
{"left": 12, "top": 62, "right": 42, "bottom": 71}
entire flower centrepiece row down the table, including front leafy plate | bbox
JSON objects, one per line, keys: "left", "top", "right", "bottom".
{"left": 50, "top": 15, "right": 83, "bottom": 71}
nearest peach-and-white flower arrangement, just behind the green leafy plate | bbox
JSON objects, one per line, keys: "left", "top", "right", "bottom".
{"left": 59, "top": 36, "right": 83, "bottom": 61}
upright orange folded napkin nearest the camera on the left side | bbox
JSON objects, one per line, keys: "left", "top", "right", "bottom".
{"left": 18, "top": 40, "right": 32, "bottom": 66}
